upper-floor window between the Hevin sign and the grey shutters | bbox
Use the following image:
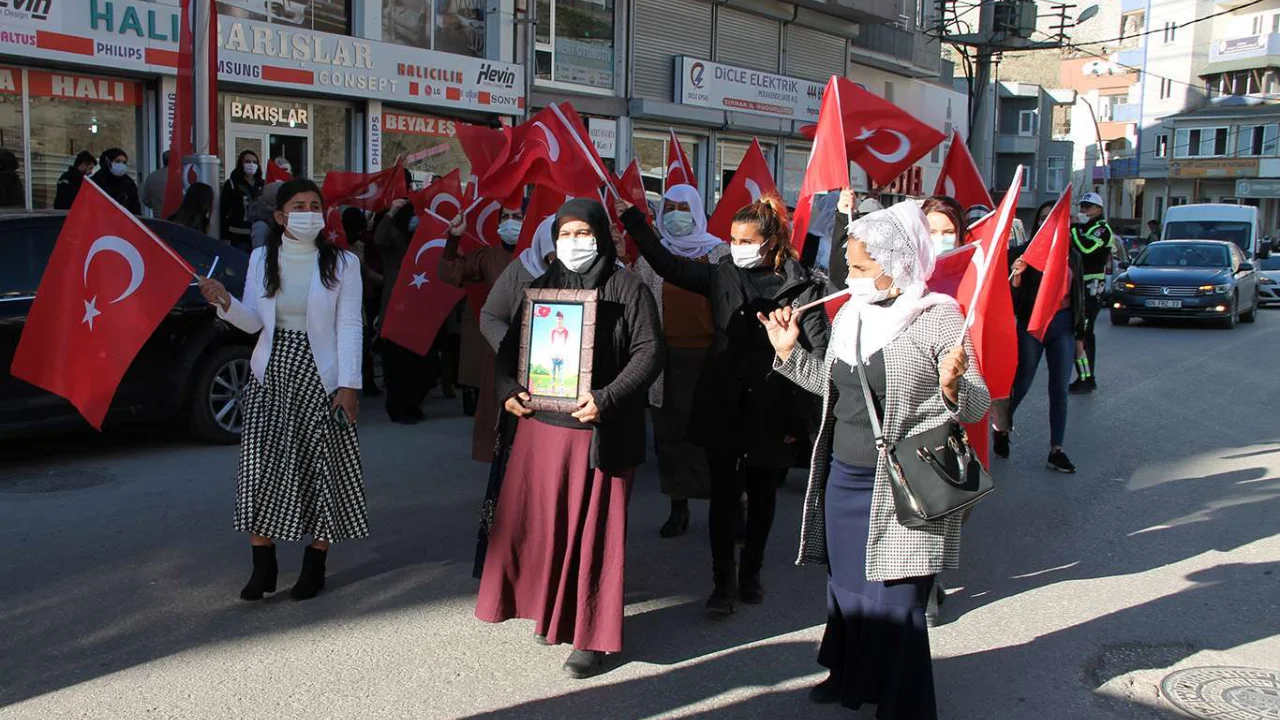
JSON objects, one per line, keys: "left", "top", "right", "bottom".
{"left": 538, "top": 0, "right": 613, "bottom": 90}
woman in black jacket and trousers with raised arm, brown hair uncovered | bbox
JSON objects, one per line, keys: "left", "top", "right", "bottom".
{"left": 618, "top": 197, "right": 828, "bottom": 614}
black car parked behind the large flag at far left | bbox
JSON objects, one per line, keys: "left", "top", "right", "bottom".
{"left": 0, "top": 213, "right": 253, "bottom": 443}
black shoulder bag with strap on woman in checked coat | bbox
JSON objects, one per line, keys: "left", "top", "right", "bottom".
{"left": 854, "top": 318, "right": 996, "bottom": 528}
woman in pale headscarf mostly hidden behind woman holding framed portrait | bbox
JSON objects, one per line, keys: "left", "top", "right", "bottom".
{"left": 471, "top": 215, "right": 556, "bottom": 579}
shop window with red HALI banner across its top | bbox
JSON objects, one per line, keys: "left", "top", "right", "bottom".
{"left": 27, "top": 70, "right": 142, "bottom": 209}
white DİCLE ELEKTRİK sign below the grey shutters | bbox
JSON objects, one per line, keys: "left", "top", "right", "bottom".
{"left": 676, "top": 55, "right": 823, "bottom": 122}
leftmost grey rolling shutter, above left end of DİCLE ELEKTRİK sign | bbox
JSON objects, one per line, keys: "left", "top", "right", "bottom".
{"left": 632, "top": 0, "right": 712, "bottom": 102}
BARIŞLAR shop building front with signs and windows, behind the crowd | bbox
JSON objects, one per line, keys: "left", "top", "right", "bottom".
{"left": 0, "top": 0, "right": 526, "bottom": 210}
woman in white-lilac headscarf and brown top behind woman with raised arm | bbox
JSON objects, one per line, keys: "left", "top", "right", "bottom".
{"left": 635, "top": 184, "right": 730, "bottom": 538}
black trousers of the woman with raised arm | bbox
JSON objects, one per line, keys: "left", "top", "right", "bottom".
{"left": 707, "top": 450, "right": 787, "bottom": 582}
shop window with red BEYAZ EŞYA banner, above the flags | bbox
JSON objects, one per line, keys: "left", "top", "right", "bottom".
{"left": 383, "top": 109, "right": 471, "bottom": 184}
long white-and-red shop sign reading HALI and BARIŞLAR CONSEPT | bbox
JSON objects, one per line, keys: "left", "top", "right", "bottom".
{"left": 0, "top": 0, "right": 525, "bottom": 115}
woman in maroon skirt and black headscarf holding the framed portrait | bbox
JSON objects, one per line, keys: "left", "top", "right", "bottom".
{"left": 476, "top": 200, "right": 662, "bottom": 678}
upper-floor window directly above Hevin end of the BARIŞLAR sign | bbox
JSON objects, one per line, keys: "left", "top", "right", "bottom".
{"left": 383, "top": 0, "right": 485, "bottom": 58}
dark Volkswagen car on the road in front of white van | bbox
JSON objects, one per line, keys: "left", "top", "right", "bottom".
{"left": 1110, "top": 240, "right": 1258, "bottom": 328}
